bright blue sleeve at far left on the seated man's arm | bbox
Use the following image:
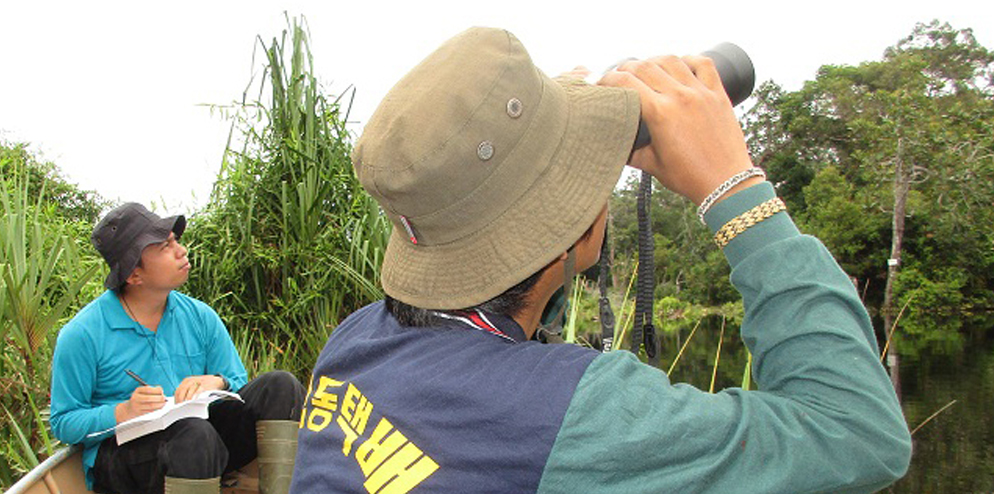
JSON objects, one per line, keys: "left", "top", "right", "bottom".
{"left": 50, "top": 328, "right": 117, "bottom": 445}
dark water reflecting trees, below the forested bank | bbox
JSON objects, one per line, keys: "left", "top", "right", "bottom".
{"left": 660, "top": 318, "right": 994, "bottom": 494}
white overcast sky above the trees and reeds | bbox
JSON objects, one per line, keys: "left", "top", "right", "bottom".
{"left": 0, "top": 0, "right": 994, "bottom": 214}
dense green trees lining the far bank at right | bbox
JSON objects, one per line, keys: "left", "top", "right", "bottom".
{"left": 612, "top": 21, "right": 994, "bottom": 350}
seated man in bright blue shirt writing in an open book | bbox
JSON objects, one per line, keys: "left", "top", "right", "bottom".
{"left": 51, "top": 203, "right": 304, "bottom": 494}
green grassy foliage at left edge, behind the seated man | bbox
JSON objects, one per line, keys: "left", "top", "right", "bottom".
{"left": 0, "top": 153, "right": 99, "bottom": 483}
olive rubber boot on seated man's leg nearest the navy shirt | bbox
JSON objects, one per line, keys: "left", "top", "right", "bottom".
{"left": 255, "top": 420, "right": 300, "bottom": 494}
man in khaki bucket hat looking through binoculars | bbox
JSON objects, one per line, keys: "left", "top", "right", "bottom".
{"left": 291, "top": 28, "right": 910, "bottom": 494}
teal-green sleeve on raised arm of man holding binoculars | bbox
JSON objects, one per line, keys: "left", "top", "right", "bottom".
{"left": 539, "top": 183, "right": 911, "bottom": 493}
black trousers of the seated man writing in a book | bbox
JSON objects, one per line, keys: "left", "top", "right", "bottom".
{"left": 93, "top": 371, "right": 306, "bottom": 494}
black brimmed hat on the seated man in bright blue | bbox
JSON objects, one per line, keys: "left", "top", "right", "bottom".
{"left": 90, "top": 202, "right": 186, "bottom": 289}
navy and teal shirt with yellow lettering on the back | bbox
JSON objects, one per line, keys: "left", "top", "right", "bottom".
{"left": 290, "top": 184, "right": 911, "bottom": 494}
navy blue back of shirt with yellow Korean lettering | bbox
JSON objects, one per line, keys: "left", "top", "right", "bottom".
{"left": 291, "top": 302, "right": 598, "bottom": 493}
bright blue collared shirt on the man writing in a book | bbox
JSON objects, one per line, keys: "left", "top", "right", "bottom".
{"left": 51, "top": 290, "right": 248, "bottom": 488}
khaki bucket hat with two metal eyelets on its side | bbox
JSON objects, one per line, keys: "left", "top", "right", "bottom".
{"left": 352, "top": 28, "right": 639, "bottom": 310}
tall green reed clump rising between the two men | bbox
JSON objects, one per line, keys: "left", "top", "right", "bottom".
{"left": 184, "top": 14, "right": 390, "bottom": 377}
